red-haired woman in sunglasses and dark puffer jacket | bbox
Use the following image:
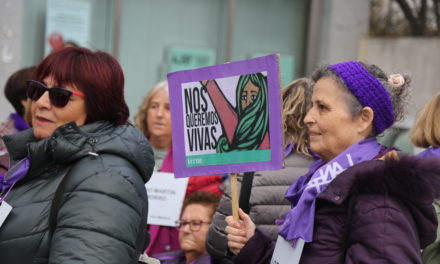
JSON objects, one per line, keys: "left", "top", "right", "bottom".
{"left": 0, "top": 47, "right": 154, "bottom": 264}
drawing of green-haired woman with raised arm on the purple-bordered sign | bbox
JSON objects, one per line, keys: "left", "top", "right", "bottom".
{"left": 202, "top": 73, "right": 269, "bottom": 153}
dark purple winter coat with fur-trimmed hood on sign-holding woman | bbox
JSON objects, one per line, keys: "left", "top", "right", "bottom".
{"left": 234, "top": 157, "right": 440, "bottom": 264}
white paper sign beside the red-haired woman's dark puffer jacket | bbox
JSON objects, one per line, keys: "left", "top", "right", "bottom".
{"left": 145, "top": 172, "right": 188, "bottom": 226}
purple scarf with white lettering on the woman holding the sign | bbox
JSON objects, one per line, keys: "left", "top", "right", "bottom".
{"left": 279, "top": 138, "right": 382, "bottom": 247}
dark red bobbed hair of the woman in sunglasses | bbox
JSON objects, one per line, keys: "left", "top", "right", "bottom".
{"left": 35, "top": 47, "right": 129, "bottom": 125}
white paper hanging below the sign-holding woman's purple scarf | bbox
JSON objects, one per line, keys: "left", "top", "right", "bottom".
{"left": 270, "top": 236, "right": 304, "bottom": 264}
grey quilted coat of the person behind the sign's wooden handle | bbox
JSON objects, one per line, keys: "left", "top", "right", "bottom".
{"left": 206, "top": 153, "right": 312, "bottom": 259}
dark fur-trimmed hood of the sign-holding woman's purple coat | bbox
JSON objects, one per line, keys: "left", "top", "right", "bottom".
{"left": 320, "top": 156, "right": 440, "bottom": 248}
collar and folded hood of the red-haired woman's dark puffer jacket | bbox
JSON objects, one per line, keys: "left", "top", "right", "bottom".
{"left": 4, "top": 121, "right": 154, "bottom": 181}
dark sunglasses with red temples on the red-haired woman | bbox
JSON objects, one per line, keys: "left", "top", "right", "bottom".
{"left": 26, "top": 80, "right": 85, "bottom": 107}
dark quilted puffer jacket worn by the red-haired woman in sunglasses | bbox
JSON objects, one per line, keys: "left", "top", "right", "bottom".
{"left": 0, "top": 122, "right": 154, "bottom": 264}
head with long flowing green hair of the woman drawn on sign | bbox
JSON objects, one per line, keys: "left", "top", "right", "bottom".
{"left": 216, "top": 73, "right": 269, "bottom": 153}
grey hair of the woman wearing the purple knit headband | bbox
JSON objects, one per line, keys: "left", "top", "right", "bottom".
{"left": 312, "top": 62, "right": 411, "bottom": 136}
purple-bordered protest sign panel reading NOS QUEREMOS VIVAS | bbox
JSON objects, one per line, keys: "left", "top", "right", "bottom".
{"left": 168, "top": 54, "right": 283, "bottom": 177}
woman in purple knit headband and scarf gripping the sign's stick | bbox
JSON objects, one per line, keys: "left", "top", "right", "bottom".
{"left": 226, "top": 61, "right": 440, "bottom": 264}
